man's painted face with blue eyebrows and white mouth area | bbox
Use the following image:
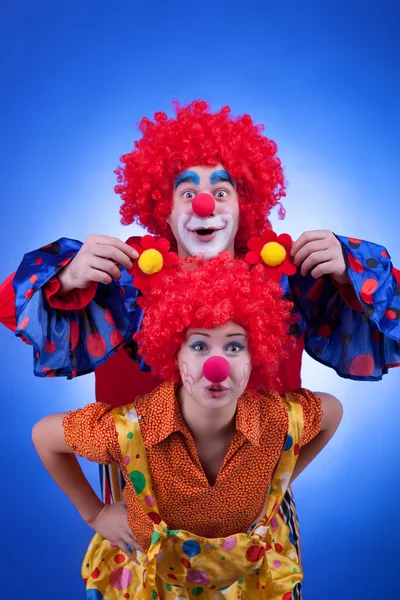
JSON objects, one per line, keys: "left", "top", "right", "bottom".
{"left": 167, "top": 165, "right": 239, "bottom": 258}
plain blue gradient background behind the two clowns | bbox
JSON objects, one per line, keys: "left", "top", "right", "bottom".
{"left": 0, "top": 0, "right": 400, "bottom": 600}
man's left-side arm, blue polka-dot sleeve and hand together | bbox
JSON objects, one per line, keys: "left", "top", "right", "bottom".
{"left": 8, "top": 236, "right": 143, "bottom": 378}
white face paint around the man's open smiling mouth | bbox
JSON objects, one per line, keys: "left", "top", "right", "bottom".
{"left": 178, "top": 214, "right": 236, "bottom": 258}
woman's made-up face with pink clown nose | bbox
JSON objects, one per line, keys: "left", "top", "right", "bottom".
{"left": 177, "top": 322, "right": 251, "bottom": 411}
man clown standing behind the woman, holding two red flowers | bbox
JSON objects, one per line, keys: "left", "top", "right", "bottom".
{"left": 0, "top": 101, "right": 400, "bottom": 597}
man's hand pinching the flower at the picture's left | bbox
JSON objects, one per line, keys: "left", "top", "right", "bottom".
{"left": 57, "top": 234, "right": 138, "bottom": 296}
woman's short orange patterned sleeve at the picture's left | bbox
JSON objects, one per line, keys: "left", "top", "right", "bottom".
{"left": 63, "top": 402, "right": 121, "bottom": 465}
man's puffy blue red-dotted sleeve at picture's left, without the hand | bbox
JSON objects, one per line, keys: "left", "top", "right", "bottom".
{"left": 13, "top": 238, "right": 146, "bottom": 378}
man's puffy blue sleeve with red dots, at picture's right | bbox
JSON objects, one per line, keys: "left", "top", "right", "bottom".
{"left": 290, "top": 236, "right": 400, "bottom": 381}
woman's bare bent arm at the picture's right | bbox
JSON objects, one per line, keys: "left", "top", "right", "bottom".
{"left": 291, "top": 392, "right": 343, "bottom": 482}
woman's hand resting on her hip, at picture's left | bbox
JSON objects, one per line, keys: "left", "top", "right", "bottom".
{"left": 86, "top": 502, "right": 144, "bottom": 564}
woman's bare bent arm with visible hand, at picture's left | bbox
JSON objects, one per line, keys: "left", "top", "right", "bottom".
{"left": 32, "top": 413, "right": 143, "bottom": 563}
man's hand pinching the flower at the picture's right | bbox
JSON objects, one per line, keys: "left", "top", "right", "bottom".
{"left": 291, "top": 230, "right": 350, "bottom": 283}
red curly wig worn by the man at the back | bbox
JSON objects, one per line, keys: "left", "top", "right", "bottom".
{"left": 115, "top": 100, "right": 285, "bottom": 247}
